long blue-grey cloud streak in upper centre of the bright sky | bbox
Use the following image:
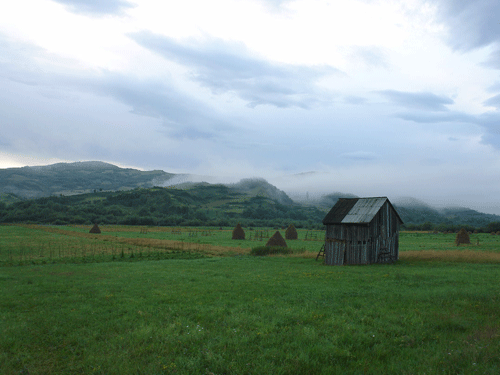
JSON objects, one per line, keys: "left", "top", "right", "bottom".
{"left": 131, "top": 32, "right": 339, "bottom": 108}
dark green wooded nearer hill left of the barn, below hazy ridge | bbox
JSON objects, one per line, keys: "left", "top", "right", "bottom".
{"left": 0, "top": 184, "right": 325, "bottom": 227}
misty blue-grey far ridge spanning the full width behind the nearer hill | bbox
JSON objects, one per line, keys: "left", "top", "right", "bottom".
{"left": 0, "top": 161, "right": 500, "bottom": 226}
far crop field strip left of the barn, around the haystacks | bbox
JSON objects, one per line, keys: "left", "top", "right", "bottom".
{"left": 0, "top": 225, "right": 324, "bottom": 265}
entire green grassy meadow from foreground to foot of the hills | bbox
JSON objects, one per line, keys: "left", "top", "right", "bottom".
{"left": 0, "top": 225, "right": 500, "bottom": 374}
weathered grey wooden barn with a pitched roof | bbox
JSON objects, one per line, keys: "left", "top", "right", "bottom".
{"left": 323, "top": 197, "right": 403, "bottom": 265}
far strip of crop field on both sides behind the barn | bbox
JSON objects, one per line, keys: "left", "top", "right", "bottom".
{"left": 0, "top": 225, "right": 500, "bottom": 265}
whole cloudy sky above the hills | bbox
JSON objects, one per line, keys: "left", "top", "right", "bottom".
{"left": 0, "top": 0, "right": 500, "bottom": 214}
